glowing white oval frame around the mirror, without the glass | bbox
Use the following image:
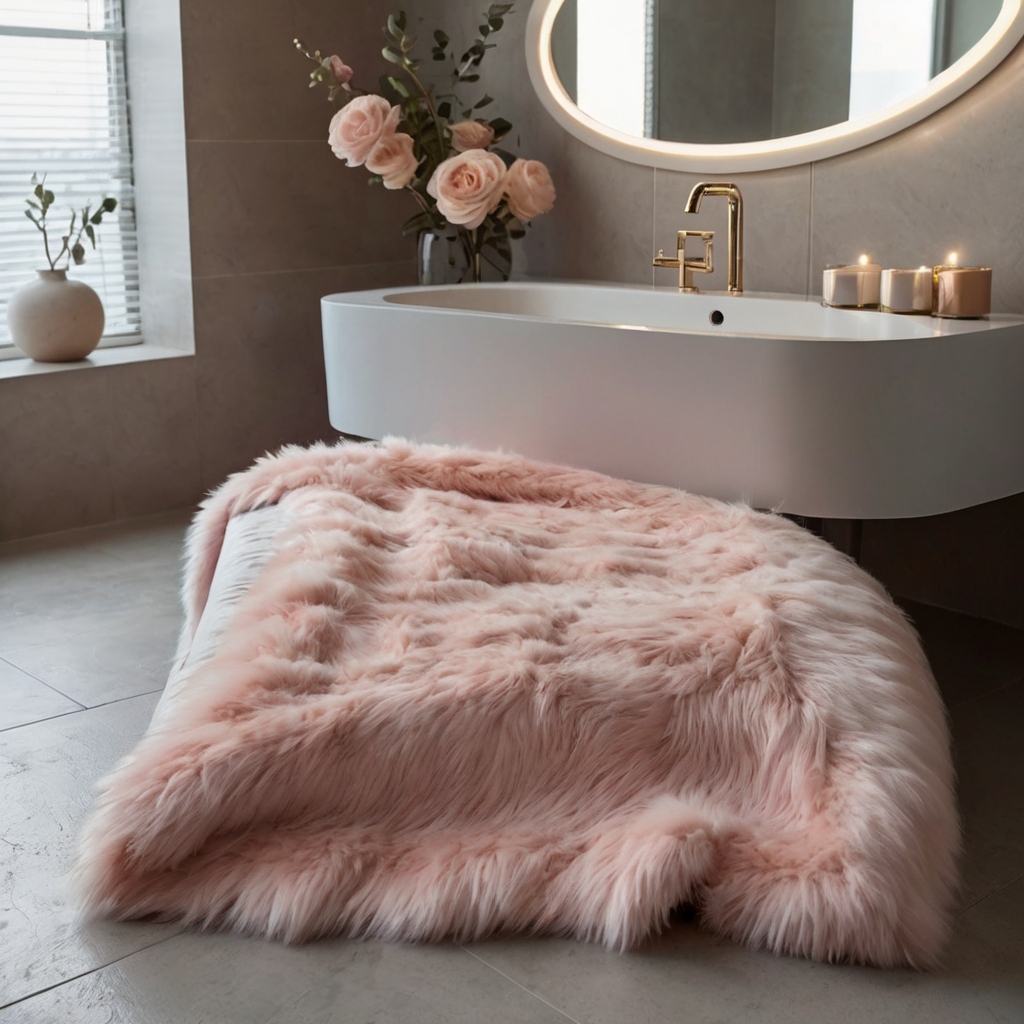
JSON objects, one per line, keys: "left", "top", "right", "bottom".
{"left": 526, "top": 0, "right": 1024, "bottom": 174}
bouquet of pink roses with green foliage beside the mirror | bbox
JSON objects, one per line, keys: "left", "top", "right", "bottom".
{"left": 295, "top": 3, "right": 555, "bottom": 281}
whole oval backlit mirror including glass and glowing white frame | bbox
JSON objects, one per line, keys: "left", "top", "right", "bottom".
{"left": 526, "top": 0, "right": 1024, "bottom": 173}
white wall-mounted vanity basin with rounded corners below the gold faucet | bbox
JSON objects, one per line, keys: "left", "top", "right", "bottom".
{"left": 322, "top": 283, "right": 1024, "bottom": 518}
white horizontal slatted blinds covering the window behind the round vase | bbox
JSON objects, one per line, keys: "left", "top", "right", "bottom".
{"left": 0, "top": 0, "right": 139, "bottom": 357}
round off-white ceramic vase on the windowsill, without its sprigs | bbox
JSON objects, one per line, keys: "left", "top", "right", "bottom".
{"left": 7, "top": 270, "right": 105, "bottom": 362}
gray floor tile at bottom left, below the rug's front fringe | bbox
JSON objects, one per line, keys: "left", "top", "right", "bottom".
{"left": 0, "top": 933, "right": 566, "bottom": 1024}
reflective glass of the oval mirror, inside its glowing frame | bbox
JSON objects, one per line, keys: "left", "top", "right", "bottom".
{"left": 552, "top": 0, "right": 1001, "bottom": 144}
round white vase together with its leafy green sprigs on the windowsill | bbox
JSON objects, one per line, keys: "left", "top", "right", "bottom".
{"left": 7, "top": 175, "right": 118, "bottom": 362}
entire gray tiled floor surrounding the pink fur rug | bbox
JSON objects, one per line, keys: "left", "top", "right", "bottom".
{"left": 0, "top": 515, "right": 1024, "bottom": 1024}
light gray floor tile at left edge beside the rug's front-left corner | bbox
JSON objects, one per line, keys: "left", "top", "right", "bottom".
{"left": 0, "top": 695, "right": 177, "bottom": 1005}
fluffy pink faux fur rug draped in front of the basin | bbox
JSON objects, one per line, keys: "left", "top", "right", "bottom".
{"left": 77, "top": 439, "right": 958, "bottom": 967}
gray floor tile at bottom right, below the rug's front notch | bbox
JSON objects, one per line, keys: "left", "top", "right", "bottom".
{"left": 469, "top": 882, "right": 1024, "bottom": 1024}
